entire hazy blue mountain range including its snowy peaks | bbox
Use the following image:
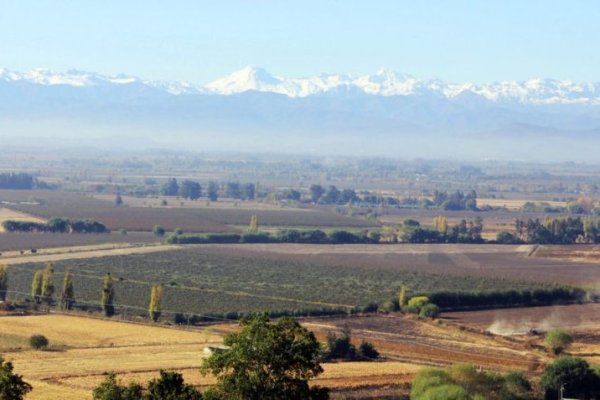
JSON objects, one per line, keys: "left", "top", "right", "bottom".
{"left": 0, "top": 67, "right": 600, "bottom": 160}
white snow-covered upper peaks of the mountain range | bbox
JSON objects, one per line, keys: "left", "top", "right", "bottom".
{"left": 0, "top": 66, "right": 600, "bottom": 105}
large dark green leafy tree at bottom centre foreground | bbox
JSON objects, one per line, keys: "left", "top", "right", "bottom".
{"left": 202, "top": 314, "right": 329, "bottom": 400}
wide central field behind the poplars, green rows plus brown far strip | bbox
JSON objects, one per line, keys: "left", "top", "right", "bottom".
{"left": 2, "top": 245, "right": 584, "bottom": 318}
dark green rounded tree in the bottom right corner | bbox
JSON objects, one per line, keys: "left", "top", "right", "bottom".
{"left": 540, "top": 356, "right": 600, "bottom": 400}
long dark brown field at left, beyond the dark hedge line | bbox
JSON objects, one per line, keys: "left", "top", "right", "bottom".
{"left": 0, "top": 190, "right": 373, "bottom": 232}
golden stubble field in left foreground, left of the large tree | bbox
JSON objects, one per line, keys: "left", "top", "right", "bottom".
{"left": 0, "top": 315, "right": 221, "bottom": 400}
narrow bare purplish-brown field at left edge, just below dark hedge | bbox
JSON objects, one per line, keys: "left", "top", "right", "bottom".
{"left": 0, "top": 232, "right": 158, "bottom": 252}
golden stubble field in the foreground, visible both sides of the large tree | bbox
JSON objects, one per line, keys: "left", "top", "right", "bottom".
{"left": 0, "top": 314, "right": 432, "bottom": 400}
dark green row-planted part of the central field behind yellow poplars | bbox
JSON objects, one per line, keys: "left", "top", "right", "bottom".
{"left": 2, "top": 245, "right": 552, "bottom": 315}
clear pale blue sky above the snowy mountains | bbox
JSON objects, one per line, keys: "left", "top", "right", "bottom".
{"left": 0, "top": 0, "right": 600, "bottom": 84}
